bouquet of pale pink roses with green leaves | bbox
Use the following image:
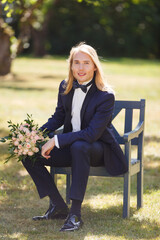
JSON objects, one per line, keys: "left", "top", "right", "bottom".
{"left": 0, "top": 114, "right": 48, "bottom": 162}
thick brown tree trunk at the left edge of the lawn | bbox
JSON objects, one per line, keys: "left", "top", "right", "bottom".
{"left": 0, "top": 25, "right": 11, "bottom": 76}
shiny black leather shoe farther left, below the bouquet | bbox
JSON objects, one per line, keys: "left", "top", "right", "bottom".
{"left": 32, "top": 205, "right": 69, "bottom": 221}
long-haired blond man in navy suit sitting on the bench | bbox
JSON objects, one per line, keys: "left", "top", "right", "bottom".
{"left": 23, "top": 43, "right": 127, "bottom": 231}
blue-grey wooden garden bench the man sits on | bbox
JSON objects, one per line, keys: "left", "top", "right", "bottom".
{"left": 51, "top": 99, "right": 145, "bottom": 218}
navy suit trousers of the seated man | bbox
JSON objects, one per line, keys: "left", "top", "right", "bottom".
{"left": 23, "top": 141, "right": 104, "bottom": 202}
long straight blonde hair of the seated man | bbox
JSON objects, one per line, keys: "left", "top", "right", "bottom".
{"left": 64, "top": 42, "right": 113, "bottom": 94}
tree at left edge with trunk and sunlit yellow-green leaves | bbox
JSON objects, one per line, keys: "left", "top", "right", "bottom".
{"left": 0, "top": 0, "right": 44, "bottom": 75}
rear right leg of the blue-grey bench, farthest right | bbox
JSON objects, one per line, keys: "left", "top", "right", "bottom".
{"left": 137, "top": 169, "right": 143, "bottom": 209}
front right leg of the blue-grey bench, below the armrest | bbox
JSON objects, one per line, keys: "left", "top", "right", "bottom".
{"left": 123, "top": 173, "right": 131, "bottom": 218}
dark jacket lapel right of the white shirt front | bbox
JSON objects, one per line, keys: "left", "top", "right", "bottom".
{"left": 81, "top": 83, "right": 97, "bottom": 124}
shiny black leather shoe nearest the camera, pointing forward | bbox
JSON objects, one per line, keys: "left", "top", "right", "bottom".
{"left": 60, "top": 214, "right": 83, "bottom": 232}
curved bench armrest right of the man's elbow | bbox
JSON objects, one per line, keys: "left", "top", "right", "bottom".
{"left": 123, "top": 121, "right": 144, "bottom": 142}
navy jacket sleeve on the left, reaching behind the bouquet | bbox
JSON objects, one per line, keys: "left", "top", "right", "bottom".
{"left": 41, "top": 81, "right": 65, "bottom": 131}
